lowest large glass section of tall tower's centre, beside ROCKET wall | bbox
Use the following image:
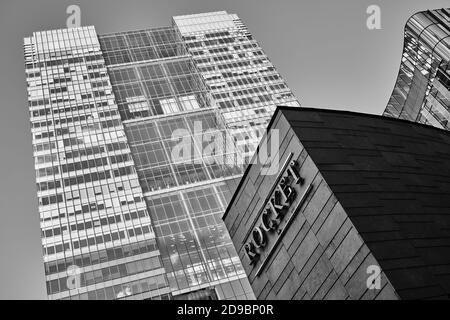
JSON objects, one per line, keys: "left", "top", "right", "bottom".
{"left": 146, "top": 182, "right": 252, "bottom": 298}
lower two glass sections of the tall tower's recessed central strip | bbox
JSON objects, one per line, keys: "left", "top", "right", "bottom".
{"left": 126, "top": 110, "right": 246, "bottom": 298}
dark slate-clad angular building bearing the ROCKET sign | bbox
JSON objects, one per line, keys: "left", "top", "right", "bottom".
{"left": 223, "top": 107, "right": 450, "bottom": 299}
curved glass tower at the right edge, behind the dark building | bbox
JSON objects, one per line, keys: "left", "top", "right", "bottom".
{"left": 384, "top": 9, "right": 450, "bottom": 130}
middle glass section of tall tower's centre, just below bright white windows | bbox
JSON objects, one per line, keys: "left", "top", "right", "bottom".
{"left": 125, "top": 111, "right": 242, "bottom": 193}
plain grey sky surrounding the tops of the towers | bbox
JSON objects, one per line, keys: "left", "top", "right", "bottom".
{"left": 0, "top": 0, "right": 450, "bottom": 299}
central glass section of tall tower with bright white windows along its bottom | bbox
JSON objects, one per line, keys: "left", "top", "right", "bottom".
{"left": 109, "top": 59, "right": 211, "bottom": 120}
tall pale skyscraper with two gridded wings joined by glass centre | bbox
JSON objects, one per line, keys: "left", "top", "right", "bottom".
{"left": 24, "top": 12, "right": 299, "bottom": 299}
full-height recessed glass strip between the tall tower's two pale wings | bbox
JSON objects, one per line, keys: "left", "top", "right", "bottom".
{"left": 101, "top": 20, "right": 254, "bottom": 299}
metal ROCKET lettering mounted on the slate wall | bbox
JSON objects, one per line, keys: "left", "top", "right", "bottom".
{"left": 244, "top": 160, "right": 304, "bottom": 265}
